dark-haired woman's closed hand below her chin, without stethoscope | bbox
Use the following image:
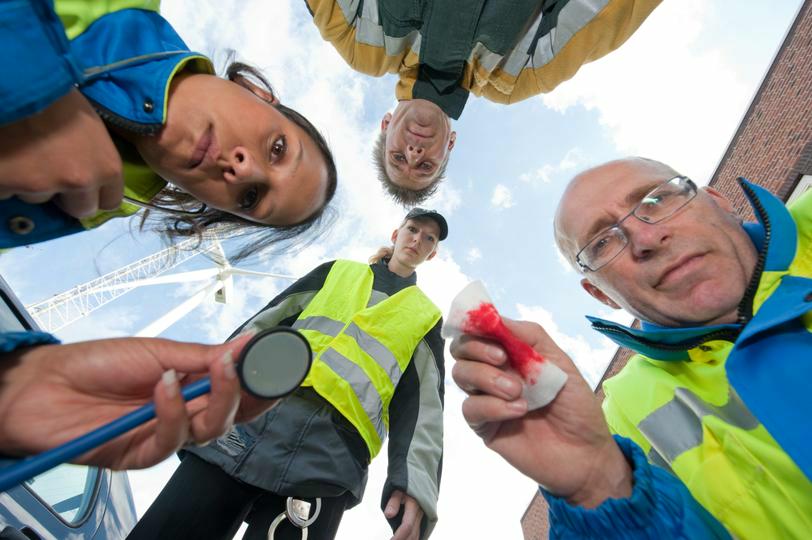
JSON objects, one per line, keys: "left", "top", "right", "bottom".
{"left": 0, "top": 89, "right": 124, "bottom": 218}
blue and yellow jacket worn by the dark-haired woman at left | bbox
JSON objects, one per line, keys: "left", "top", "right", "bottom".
{"left": 0, "top": 0, "right": 213, "bottom": 248}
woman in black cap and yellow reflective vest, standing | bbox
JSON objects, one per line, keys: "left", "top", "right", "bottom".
{"left": 135, "top": 208, "right": 448, "bottom": 540}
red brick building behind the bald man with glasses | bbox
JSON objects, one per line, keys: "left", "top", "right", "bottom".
{"left": 522, "top": 0, "right": 812, "bottom": 540}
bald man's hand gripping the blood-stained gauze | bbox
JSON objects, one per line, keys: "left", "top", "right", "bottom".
{"left": 451, "top": 320, "right": 632, "bottom": 508}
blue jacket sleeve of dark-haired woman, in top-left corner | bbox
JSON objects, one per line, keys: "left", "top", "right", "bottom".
{"left": 0, "top": 0, "right": 81, "bottom": 125}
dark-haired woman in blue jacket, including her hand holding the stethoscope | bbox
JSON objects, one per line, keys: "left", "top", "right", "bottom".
{"left": 0, "top": 0, "right": 336, "bottom": 480}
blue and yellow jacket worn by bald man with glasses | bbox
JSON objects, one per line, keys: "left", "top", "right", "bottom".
{"left": 545, "top": 181, "right": 812, "bottom": 539}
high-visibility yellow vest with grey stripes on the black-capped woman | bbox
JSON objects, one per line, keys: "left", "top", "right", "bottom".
{"left": 293, "top": 260, "right": 440, "bottom": 460}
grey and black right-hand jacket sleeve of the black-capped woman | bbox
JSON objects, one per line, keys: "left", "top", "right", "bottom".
{"left": 381, "top": 320, "right": 445, "bottom": 538}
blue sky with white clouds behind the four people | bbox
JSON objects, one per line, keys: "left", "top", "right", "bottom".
{"left": 0, "top": 0, "right": 801, "bottom": 540}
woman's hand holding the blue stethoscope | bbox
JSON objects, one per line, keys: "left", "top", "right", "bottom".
{"left": 0, "top": 336, "right": 275, "bottom": 469}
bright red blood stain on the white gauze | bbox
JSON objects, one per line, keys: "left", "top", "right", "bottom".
{"left": 463, "top": 302, "right": 544, "bottom": 384}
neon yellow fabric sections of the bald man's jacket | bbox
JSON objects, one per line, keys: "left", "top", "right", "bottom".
{"left": 604, "top": 192, "right": 812, "bottom": 539}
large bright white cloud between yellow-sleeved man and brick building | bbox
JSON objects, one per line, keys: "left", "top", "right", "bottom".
{"left": 539, "top": 0, "right": 751, "bottom": 183}
